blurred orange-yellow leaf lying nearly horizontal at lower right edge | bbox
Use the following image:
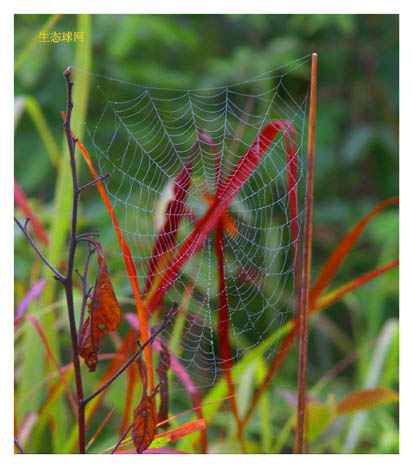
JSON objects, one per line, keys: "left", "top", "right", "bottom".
{"left": 336, "top": 387, "right": 399, "bottom": 415}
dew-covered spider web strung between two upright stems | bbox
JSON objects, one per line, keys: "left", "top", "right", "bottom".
{"left": 75, "top": 56, "right": 309, "bottom": 387}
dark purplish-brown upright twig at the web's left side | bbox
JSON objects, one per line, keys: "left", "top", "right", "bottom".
{"left": 63, "top": 67, "right": 86, "bottom": 453}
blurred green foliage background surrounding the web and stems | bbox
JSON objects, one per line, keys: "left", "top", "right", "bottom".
{"left": 15, "top": 15, "right": 399, "bottom": 453}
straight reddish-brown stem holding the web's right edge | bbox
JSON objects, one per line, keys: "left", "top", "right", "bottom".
{"left": 295, "top": 54, "right": 317, "bottom": 453}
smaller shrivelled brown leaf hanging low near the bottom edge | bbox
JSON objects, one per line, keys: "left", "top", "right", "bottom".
{"left": 132, "top": 359, "right": 156, "bottom": 453}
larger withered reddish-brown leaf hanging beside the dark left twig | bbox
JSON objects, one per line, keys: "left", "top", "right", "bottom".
{"left": 79, "top": 243, "right": 120, "bottom": 372}
